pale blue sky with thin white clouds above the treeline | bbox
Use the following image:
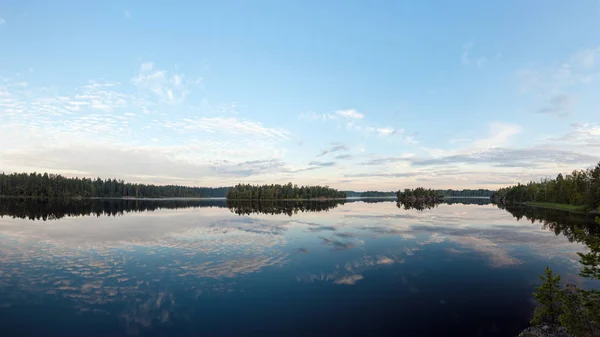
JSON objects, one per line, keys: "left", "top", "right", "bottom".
{"left": 0, "top": 0, "right": 600, "bottom": 191}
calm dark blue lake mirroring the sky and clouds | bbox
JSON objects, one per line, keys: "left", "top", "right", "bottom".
{"left": 0, "top": 199, "right": 597, "bottom": 337}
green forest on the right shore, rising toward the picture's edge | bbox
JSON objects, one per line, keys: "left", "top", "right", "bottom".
{"left": 492, "top": 163, "right": 600, "bottom": 209}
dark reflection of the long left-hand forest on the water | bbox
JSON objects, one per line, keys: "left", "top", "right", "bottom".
{"left": 0, "top": 198, "right": 227, "bottom": 221}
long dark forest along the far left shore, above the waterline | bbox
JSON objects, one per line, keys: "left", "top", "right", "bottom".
{"left": 0, "top": 173, "right": 228, "bottom": 198}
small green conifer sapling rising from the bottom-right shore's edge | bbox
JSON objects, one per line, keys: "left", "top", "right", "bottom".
{"left": 531, "top": 266, "right": 562, "bottom": 325}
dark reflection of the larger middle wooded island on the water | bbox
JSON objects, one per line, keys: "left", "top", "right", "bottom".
{"left": 227, "top": 199, "right": 345, "bottom": 216}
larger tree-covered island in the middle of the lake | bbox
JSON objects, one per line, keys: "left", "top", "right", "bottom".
{"left": 227, "top": 183, "right": 346, "bottom": 200}
